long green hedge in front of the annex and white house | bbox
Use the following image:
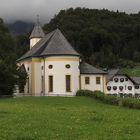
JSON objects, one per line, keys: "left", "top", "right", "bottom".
{"left": 76, "top": 90, "right": 140, "bottom": 109}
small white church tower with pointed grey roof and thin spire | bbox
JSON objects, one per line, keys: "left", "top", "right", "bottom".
{"left": 30, "top": 16, "right": 45, "bottom": 49}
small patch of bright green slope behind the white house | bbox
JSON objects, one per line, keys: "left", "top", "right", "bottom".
{"left": 124, "top": 66, "right": 140, "bottom": 76}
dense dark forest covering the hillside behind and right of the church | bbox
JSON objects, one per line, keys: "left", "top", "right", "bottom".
{"left": 44, "top": 8, "right": 140, "bottom": 68}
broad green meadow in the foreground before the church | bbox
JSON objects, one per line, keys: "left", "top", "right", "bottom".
{"left": 0, "top": 97, "right": 140, "bottom": 140}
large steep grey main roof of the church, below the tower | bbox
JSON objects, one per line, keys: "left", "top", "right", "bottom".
{"left": 17, "top": 29, "right": 80, "bottom": 61}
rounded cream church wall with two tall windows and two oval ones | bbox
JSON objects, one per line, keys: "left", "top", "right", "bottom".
{"left": 45, "top": 57, "right": 80, "bottom": 96}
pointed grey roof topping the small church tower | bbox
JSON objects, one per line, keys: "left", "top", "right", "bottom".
{"left": 30, "top": 24, "right": 45, "bottom": 39}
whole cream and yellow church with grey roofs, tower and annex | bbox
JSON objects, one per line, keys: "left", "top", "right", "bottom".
{"left": 17, "top": 23, "right": 107, "bottom": 96}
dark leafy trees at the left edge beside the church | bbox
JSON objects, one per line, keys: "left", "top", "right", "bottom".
{"left": 0, "top": 19, "right": 26, "bottom": 96}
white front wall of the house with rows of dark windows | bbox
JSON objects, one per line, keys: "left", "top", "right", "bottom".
{"left": 106, "top": 75, "right": 135, "bottom": 94}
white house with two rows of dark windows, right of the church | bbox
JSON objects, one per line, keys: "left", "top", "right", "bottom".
{"left": 106, "top": 69, "right": 140, "bottom": 97}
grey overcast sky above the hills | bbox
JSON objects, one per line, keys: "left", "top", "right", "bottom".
{"left": 0, "top": 0, "right": 140, "bottom": 23}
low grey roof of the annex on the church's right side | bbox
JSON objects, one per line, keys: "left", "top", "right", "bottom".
{"left": 80, "top": 62, "right": 107, "bottom": 74}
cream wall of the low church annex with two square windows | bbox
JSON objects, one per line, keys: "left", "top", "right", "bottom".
{"left": 81, "top": 74, "right": 105, "bottom": 92}
